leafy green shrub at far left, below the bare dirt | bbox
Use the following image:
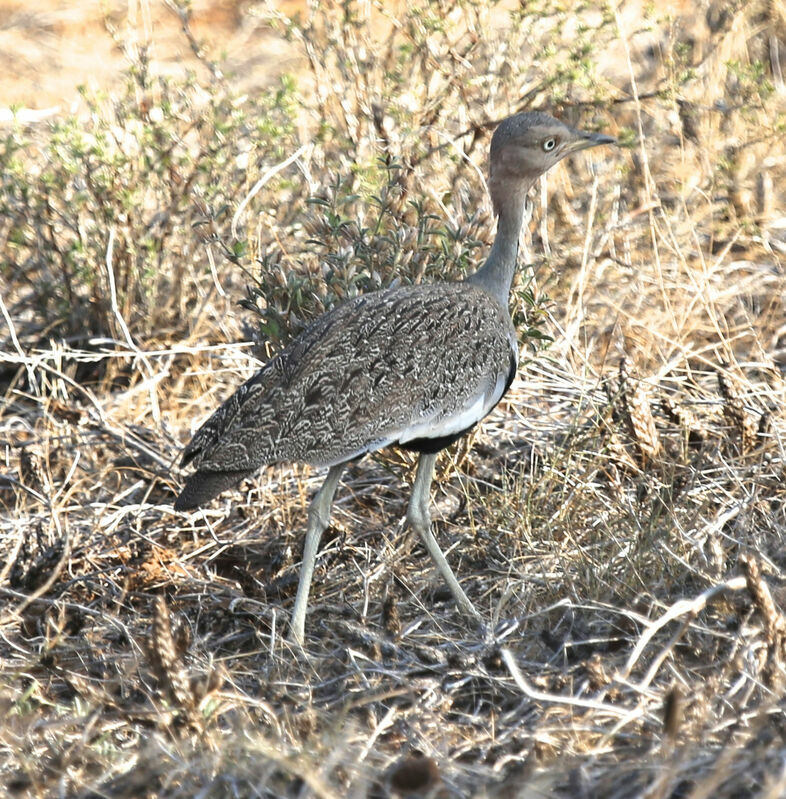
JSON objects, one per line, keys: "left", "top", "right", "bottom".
{"left": 0, "top": 65, "right": 294, "bottom": 345}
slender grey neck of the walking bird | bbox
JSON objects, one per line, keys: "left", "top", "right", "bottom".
{"left": 467, "top": 186, "right": 529, "bottom": 308}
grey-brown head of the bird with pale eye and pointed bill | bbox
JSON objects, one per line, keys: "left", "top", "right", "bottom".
{"left": 489, "top": 111, "right": 616, "bottom": 214}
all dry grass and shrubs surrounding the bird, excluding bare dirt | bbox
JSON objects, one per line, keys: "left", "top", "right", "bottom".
{"left": 0, "top": 0, "right": 786, "bottom": 799}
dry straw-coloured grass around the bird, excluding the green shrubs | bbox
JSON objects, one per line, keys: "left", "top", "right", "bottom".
{"left": 0, "top": 3, "right": 786, "bottom": 799}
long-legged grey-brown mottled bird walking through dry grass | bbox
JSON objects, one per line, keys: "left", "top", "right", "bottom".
{"left": 174, "top": 111, "right": 616, "bottom": 646}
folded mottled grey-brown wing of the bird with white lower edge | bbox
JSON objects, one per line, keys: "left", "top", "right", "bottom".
{"left": 183, "top": 283, "right": 517, "bottom": 473}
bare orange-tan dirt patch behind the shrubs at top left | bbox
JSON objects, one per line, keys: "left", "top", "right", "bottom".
{"left": 0, "top": 0, "right": 302, "bottom": 110}
